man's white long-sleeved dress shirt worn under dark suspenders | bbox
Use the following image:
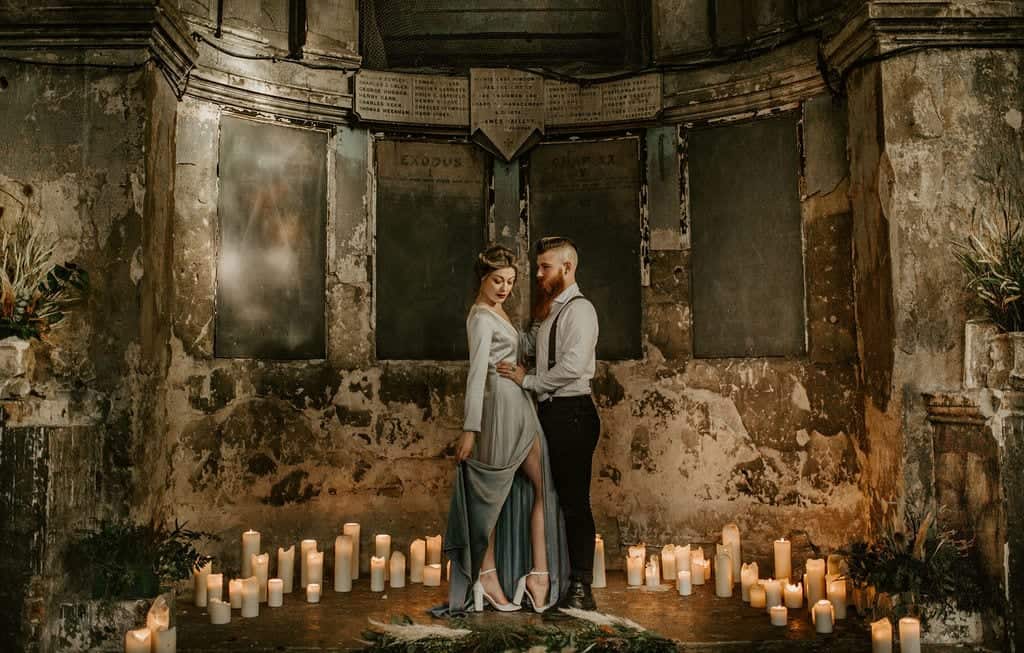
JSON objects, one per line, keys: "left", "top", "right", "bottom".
{"left": 522, "top": 284, "right": 598, "bottom": 401}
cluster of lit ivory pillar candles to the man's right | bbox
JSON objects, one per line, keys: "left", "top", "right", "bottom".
{"left": 594, "top": 524, "right": 921, "bottom": 653}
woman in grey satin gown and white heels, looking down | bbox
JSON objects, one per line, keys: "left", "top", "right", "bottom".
{"left": 441, "top": 246, "right": 569, "bottom": 613}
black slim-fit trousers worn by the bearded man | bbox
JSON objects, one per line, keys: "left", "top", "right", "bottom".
{"left": 538, "top": 395, "right": 601, "bottom": 584}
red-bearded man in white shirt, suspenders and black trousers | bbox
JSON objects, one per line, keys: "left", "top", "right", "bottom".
{"left": 498, "top": 236, "right": 601, "bottom": 610}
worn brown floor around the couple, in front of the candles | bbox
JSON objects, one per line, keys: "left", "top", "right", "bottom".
{"left": 177, "top": 572, "right": 991, "bottom": 653}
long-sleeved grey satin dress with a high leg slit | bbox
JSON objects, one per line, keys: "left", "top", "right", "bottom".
{"left": 435, "top": 304, "right": 569, "bottom": 614}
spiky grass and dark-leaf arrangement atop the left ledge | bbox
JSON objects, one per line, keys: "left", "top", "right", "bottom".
{"left": 0, "top": 217, "right": 89, "bottom": 340}
